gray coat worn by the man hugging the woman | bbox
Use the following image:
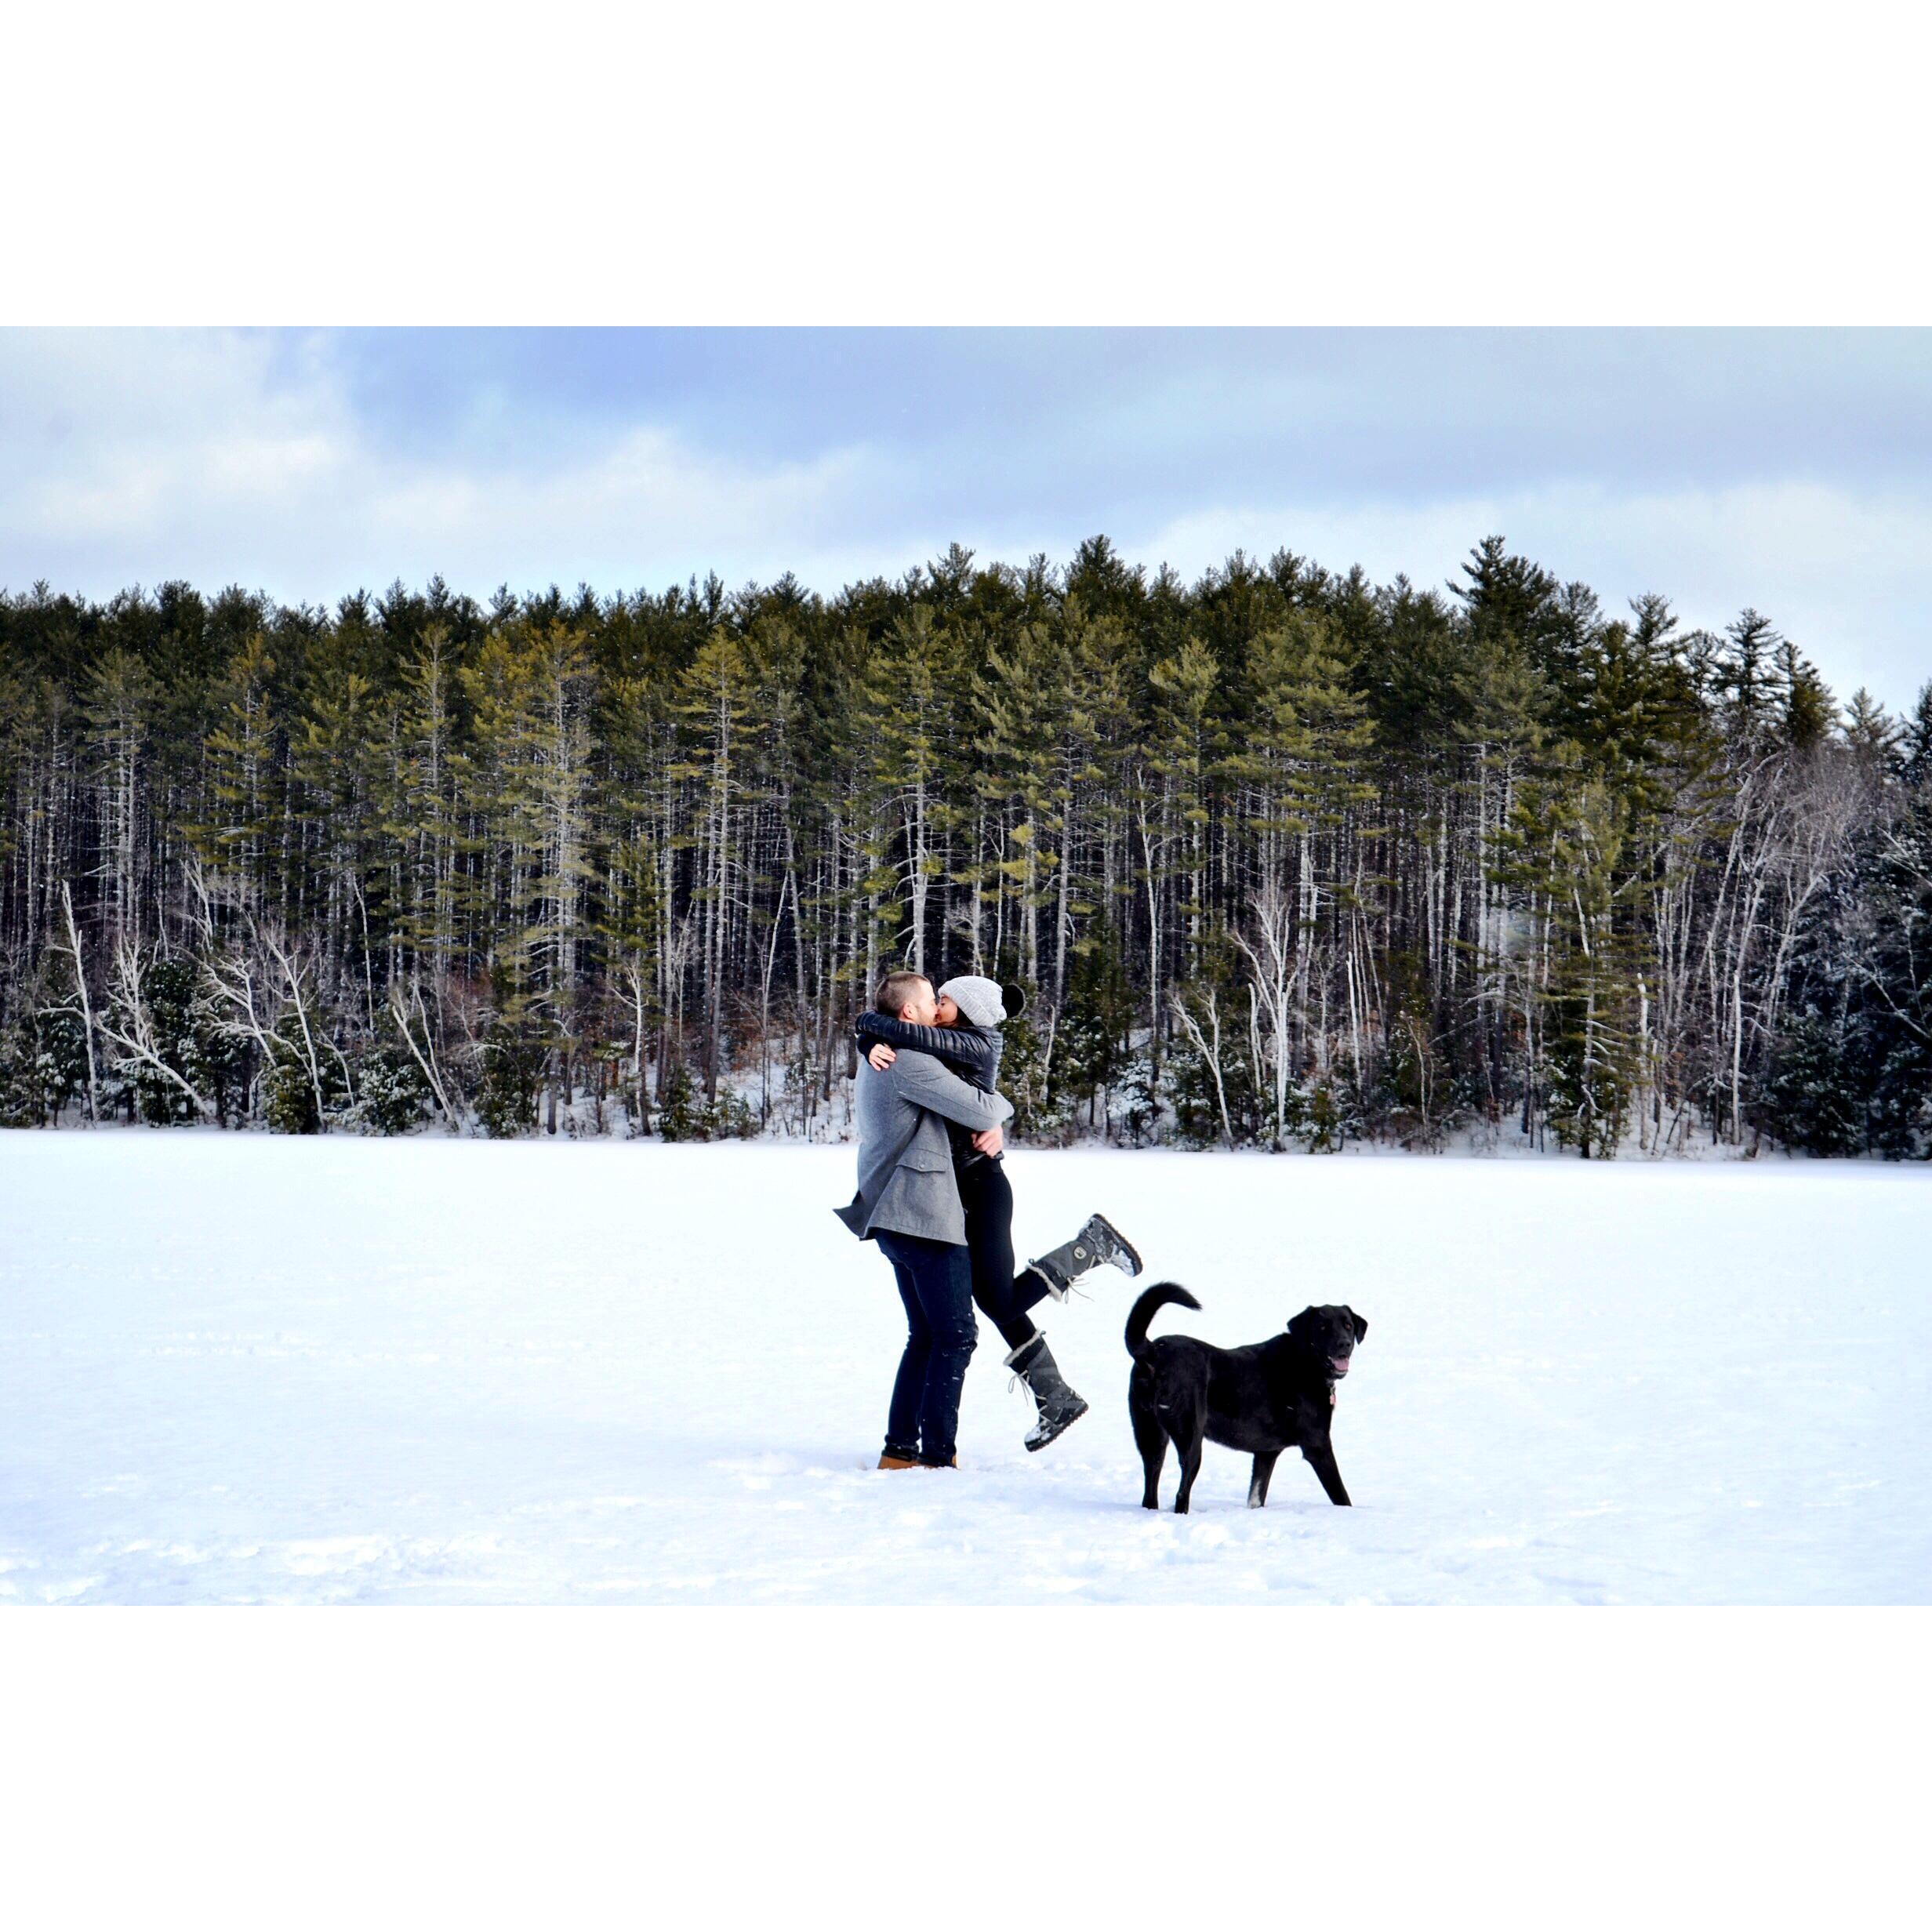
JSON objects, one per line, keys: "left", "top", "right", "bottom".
{"left": 834, "top": 1053, "right": 1012, "bottom": 1246}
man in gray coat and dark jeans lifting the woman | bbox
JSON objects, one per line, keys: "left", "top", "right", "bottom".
{"left": 837, "top": 971, "right": 1012, "bottom": 1469}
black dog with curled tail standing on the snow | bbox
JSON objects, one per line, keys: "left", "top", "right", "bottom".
{"left": 1127, "top": 1281, "right": 1368, "bottom": 1516}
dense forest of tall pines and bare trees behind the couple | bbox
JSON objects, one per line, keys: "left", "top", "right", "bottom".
{"left": 0, "top": 537, "right": 1932, "bottom": 1159}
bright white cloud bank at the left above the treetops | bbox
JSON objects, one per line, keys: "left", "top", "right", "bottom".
{"left": 0, "top": 332, "right": 902, "bottom": 601}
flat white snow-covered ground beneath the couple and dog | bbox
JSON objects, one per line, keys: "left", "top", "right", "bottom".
{"left": 0, "top": 1130, "right": 1932, "bottom": 1603}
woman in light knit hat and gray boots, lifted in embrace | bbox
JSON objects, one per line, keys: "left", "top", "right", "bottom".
{"left": 858, "top": 974, "right": 1140, "bottom": 1449}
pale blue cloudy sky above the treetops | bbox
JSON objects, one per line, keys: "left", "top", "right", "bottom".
{"left": 0, "top": 329, "right": 1932, "bottom": 709}
